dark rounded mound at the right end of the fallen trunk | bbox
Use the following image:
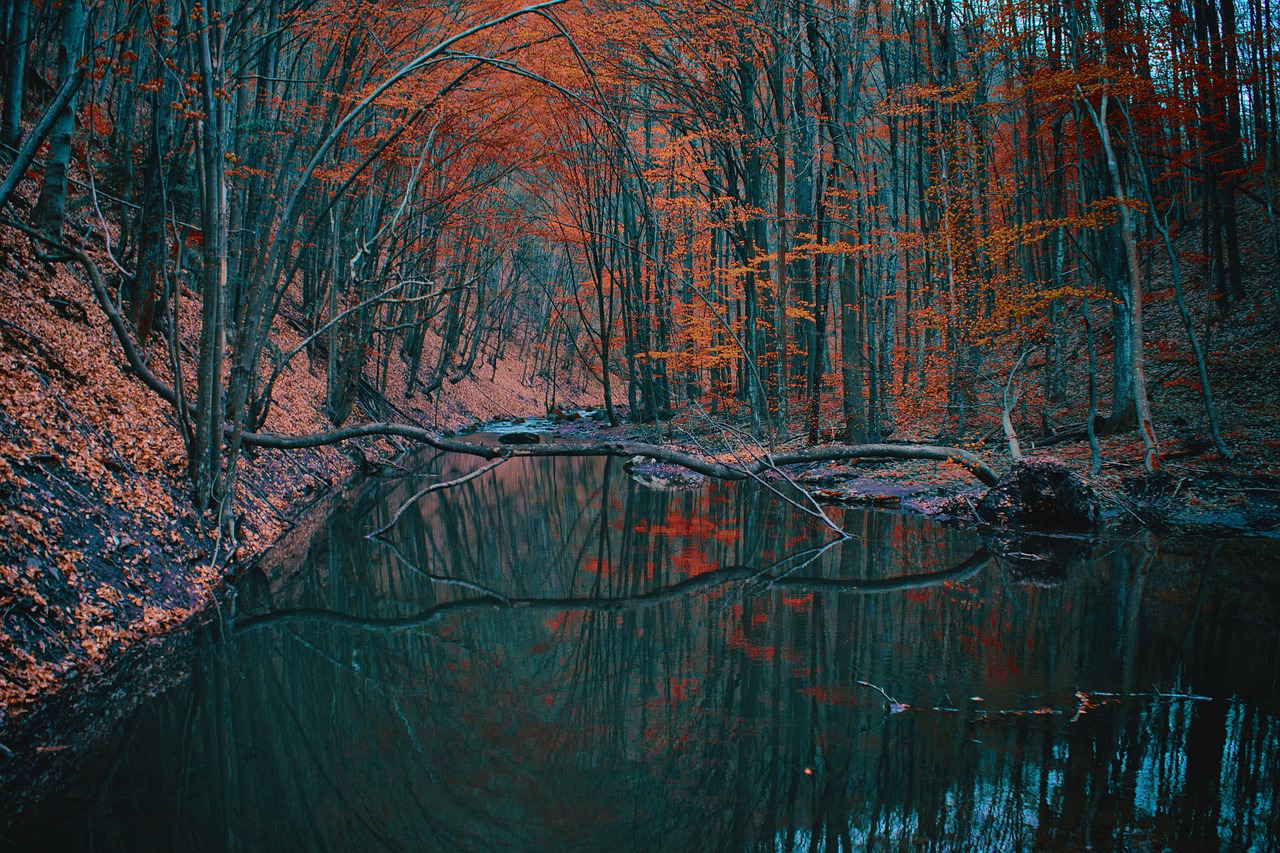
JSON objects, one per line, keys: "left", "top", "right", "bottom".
{"left": 978, "top": 457, "right": 1101, "bottom": 532}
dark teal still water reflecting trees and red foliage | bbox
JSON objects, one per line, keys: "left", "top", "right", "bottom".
{"left": 10, "top": 448, "right": 1280, "bottom": 850}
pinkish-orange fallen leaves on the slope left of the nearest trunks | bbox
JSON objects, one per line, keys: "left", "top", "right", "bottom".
{"left": 0, "top": 229, "right": 210, "bottom": 716}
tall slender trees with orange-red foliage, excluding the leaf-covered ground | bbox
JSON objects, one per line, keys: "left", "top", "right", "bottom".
{"left": 0, "top": 0, "right": 1280, "bottom": 507}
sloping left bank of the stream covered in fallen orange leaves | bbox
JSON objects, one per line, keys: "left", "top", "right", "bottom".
{"left": 0, "top": 219, "right": 581, "bottom": 742}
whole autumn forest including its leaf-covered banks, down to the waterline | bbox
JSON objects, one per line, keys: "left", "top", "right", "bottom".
{"left": 0, "top": 0, "right": 1280, "bottom": 838}
